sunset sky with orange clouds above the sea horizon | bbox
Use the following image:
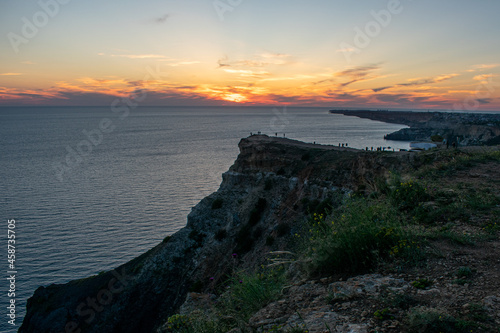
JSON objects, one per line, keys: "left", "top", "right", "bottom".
{"left": 0, "top": 0, "right": 500, "bottom": 111}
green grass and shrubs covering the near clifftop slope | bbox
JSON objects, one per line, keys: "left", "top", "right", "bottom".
{"left": 163, "top": 150, "right": 500, "bottom": 332}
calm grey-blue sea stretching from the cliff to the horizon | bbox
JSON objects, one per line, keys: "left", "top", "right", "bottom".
{"left": 0, "top": 107, "right": 408, "bottom": 332}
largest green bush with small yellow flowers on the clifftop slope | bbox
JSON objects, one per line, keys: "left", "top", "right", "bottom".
{"left": 306, "top": 199, "right": 414, "bottom": 275}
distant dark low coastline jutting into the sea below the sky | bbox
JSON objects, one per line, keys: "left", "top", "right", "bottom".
{"left": 330, "top": 110, "right": 500, "bottom": 146}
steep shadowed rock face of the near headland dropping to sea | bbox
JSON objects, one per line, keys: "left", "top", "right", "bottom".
{"left": 19, "top": 135, "right": 418, "bottom": 333}
